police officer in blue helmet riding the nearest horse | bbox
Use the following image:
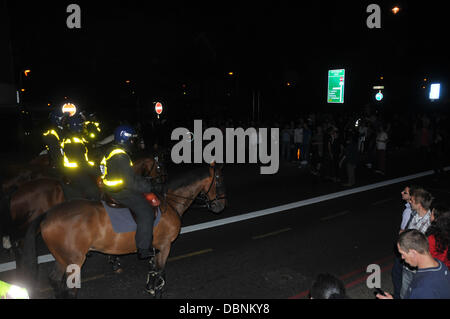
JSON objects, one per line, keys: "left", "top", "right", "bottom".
{"left": 100, "top": 125, "right": 160, "bottom": 259}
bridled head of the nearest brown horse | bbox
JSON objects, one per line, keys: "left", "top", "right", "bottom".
{"left": 202, "top": 163, "right": 226, "bottom": 214}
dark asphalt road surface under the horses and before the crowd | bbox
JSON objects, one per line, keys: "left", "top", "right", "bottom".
{"left": 0, "top": 150, "right": 450, "bottom": 299}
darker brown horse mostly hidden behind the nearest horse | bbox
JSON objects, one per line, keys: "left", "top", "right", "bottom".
{"left": 0, "top": 158, "right": 167, "bottom": 252}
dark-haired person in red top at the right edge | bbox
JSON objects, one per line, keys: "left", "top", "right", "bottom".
{"left": 426, "top": 204, "right": 450, "bottom": 267}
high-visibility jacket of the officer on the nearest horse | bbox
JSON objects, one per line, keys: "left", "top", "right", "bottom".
{"left": 100, "top": 146, "right": 152, "bottom": 193}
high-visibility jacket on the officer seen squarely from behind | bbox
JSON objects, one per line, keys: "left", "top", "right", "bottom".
{"left": 61, "top": 136, "right": 95, "bottom": 170}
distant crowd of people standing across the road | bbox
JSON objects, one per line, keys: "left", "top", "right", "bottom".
{"left": 277, "top": 112, "right": 449, "bottom": 186}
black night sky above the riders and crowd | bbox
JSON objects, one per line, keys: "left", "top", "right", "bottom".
{"left": 3, "top": 0, "right": 450, "bottom": 119}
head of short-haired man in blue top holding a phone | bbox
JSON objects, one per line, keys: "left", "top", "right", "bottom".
{"left": 397, "top": 229, "right": 430, "bottom": 267}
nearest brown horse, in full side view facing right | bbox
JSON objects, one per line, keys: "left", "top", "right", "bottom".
{"left": 25, "top": 164, "right": 225, "bottom": 297}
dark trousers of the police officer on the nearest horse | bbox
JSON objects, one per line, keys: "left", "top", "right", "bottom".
{"left": 106, "top": 188, "right": 155, "bottom": 249}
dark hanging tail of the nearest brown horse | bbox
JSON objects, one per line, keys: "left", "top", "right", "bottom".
{"left": 21, "top": 212, "right": 47, "bottom": 287}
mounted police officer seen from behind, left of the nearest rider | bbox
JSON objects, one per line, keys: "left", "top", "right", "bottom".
{"left": 61, "top": 115, "right": 100, "bottom": 200}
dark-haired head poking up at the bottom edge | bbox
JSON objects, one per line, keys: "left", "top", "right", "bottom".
{"left": 309, "top": 274, "right": 348, "bottom": 299}
